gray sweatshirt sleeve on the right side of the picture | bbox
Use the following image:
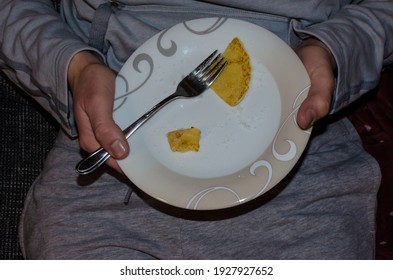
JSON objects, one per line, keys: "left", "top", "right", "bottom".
{"left": 296, "top": 0, "right": 393, "bottom": 113}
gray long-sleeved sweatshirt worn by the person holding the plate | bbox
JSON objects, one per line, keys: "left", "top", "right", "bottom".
{"left": 0, "top": 0, "right": 393, "bottom": 135}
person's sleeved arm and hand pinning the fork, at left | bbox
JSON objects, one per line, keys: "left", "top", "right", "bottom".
{"left": 0, "top": 0, "right": 129, "bottom": 171}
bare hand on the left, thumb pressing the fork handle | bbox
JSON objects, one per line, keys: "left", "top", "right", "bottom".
{"left": 68, "top": 51, "right": 129, "bottom": 172}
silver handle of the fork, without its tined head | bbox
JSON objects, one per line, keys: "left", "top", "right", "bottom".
{"left": 75, "top": 93, "right": 180, "bottom": 175}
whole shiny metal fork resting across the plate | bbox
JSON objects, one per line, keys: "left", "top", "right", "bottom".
{"left": 76, "top": 50, "right": 227, "bottom": 174}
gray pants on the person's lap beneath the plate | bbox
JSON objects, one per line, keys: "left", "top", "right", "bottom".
{"left": 20, "top": 117, "right": 380, "bottom": 259}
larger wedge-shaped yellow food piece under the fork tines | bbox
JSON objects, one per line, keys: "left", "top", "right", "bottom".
{"left": 211, "top": 37, "right": 251, "bottom": 106}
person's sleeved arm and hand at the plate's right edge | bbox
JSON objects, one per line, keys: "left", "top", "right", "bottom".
{"left": 296, "top": 0, "right": 393, "bottom": 128}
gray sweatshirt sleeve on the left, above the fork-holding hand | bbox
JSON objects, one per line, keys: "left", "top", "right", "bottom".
{"left": 0, "top": 0, "right": 99, "bottom": 135}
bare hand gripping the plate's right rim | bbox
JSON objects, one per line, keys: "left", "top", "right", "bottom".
{"left": 296, "top": 38, "right": 336, "bottom": 129}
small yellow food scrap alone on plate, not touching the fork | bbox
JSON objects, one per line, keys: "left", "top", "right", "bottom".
{"left": 167, "top": 127, "right": 201, "bottom": 153}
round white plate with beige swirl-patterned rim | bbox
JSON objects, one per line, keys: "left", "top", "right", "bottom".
{"left": 114, "top": 18, "right": 310, "bottom": 210}
